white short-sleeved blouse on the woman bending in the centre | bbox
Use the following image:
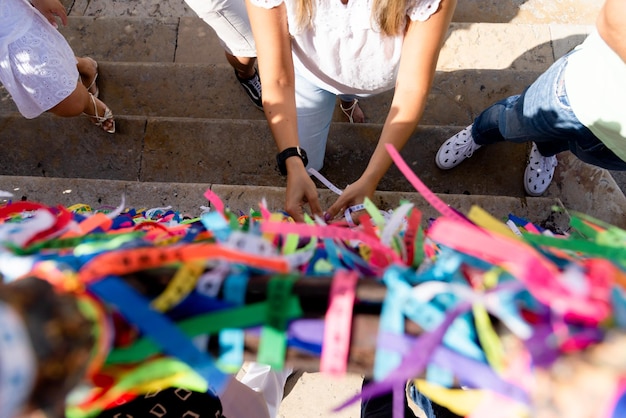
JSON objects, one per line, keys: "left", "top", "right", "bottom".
{"left": 251, "top": 0, "right": 440, "bottom": 95}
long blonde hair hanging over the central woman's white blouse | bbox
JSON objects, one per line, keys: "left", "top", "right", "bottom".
{"left": 296, "top": 0, "right": 407, "bottom": 36}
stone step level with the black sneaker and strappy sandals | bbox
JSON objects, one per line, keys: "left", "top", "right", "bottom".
{"left": 0, "top": 61, "right": 539, "bottom": 125}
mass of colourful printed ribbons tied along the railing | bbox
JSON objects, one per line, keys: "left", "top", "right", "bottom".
{"left": 0, "top": 147, "right": 626, "bottom": 418}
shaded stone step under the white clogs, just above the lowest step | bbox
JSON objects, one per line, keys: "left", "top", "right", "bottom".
{"left": 0, "top": 113, "right": 626, "bottom": 226}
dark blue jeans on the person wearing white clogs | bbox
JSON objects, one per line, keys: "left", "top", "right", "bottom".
{"left": 472, "top": 51, "right": 626, "bottom": 170}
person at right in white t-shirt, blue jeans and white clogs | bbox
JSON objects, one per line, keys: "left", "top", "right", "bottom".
{"left": 435, "top": 0, "right": 626, "bottom": 196}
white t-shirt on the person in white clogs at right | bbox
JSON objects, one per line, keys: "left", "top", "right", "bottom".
{"left": 564, "top": 31, "right": 626, "bottom": 161}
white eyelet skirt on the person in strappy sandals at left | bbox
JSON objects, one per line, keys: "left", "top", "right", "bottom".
{"left": 0, "top": 6, "right": 79, "bottom": 119}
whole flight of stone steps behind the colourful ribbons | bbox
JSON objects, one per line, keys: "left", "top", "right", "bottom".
{"left": 0, "top": 0, "right": 626, "bottom": 227}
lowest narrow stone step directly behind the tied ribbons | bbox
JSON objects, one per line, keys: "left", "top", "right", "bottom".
{"left": 0, "top": 176, "right": 569, "bottom": 231}
